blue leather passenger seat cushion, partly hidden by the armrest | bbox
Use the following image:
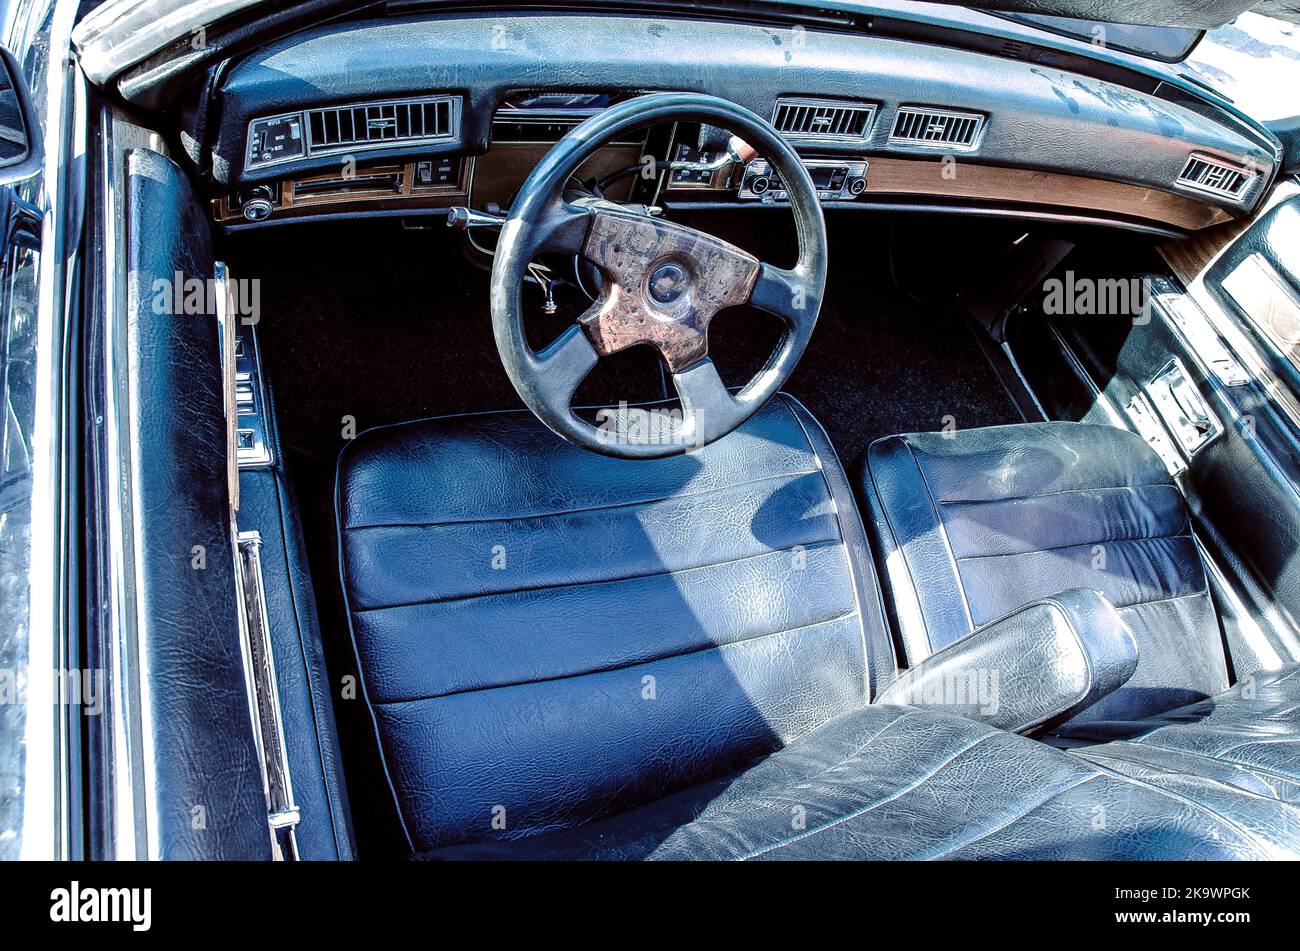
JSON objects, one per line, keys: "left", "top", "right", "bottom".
{"left": 861, "top": 422, "right": 1227, "bottom": 721}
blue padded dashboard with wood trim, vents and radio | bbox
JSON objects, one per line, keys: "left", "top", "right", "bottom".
{"left": 203, "top": 14, "right": 1279, "bottom": 233}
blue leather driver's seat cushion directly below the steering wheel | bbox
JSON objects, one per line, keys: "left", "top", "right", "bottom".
{"left": 337, "top": 389, "right": 893, "bottom": 850}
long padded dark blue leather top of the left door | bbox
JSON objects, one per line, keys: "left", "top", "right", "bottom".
{"left": 124, "top": 149, "right": 270, "bottom": 860}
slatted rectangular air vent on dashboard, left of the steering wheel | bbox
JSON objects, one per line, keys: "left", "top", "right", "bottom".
{"left": 307, "top": 96, "right": 460, "bottom": 155}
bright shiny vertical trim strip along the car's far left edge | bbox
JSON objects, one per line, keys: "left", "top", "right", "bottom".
{"left": 5, "top": 0, "right": 87, "bottom": 859}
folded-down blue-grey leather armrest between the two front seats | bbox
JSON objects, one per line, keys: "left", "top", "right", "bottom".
{"left": 875, "top": 587, "right": 1138, "bottom": 733}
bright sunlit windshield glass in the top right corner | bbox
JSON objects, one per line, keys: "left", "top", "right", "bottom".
{"left": 1186, "top": 13, "right": 1300, "bottom": 122}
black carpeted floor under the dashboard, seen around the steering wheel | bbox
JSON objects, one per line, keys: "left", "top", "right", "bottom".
{"left": 224, "top": 214, "right": 1019, "bottom": 465}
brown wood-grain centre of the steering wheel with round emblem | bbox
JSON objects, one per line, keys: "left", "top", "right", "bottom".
{"left": 579, "top": 210, "right": 759, "bottom": 373}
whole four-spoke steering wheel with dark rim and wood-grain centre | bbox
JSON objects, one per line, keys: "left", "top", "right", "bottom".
{"left": 491, "top": 92, "right": 827, "bottom": 459}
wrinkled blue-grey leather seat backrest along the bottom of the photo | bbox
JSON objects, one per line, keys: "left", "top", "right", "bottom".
{"left": 426, "top": 668, "right": 1300, "bottom": 860}
